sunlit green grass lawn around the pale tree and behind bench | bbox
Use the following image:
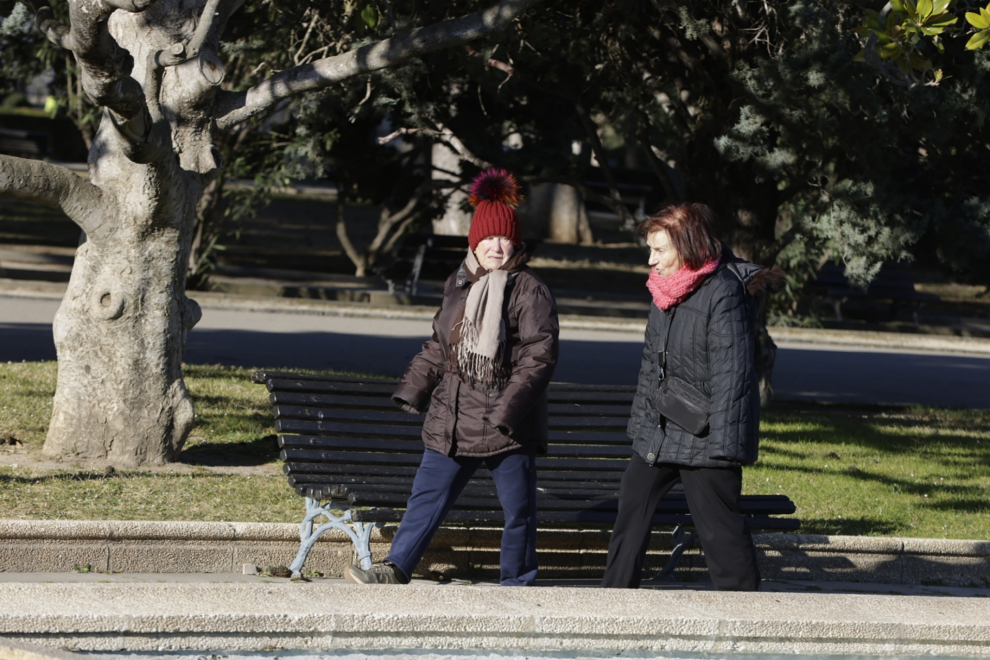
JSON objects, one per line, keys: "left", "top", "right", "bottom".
{"left": 0, "top": 362, "right": 990, "bottom": 539}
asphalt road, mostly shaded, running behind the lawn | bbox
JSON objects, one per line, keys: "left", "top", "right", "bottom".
{"left": 0, "top": 297, "right": 990, "bottom": 408}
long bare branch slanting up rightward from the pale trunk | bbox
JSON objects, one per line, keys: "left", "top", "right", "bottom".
{"left": 217, "top": 0, "right": 539, "bottom": 129}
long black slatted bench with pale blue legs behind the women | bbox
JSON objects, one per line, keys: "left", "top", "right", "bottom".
{"left": 252, "top": 371, "right": 800, "bottom": 579}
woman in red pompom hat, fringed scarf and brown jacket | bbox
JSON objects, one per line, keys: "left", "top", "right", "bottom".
{"left": 345, "top": 169, "right": 558, "bottom": 586}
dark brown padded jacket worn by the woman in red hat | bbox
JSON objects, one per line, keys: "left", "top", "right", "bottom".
{"left": 392, "top": 264, "right": 559, "bottom": 456}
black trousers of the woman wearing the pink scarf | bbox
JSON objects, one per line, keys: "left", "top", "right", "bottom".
{"left": 601, "top": 453, "right": 760, "bottom": 591}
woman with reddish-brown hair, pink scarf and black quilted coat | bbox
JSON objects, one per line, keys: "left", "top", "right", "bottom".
{"left": 602, "top": 204, "right": 779, "bottom": 591}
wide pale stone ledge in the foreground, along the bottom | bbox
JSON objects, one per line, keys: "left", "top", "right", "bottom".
{"left": 0, "top": 573, "right": 990, "bottom": 658}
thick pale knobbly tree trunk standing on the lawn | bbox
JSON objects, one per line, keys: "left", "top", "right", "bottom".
{"left": 43, "top": 129, "right": 201, "bottom": 466}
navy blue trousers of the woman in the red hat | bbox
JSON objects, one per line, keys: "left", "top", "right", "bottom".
{"left": 385, "top": 447, "right": 537, "bottom": 587}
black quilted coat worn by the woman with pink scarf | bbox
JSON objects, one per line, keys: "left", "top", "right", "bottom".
{"left": 627, "top": 254, "right": 763, "bottom": 468}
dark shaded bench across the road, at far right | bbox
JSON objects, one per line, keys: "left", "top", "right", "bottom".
{"left": 810, "top": 261, "right": 940, "bottom": 325}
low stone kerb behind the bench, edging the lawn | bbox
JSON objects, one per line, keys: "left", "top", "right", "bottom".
{"left": 0, "top": 520, "right": 990, "bottom": 587}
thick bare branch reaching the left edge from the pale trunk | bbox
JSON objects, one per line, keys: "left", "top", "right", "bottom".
{"left": 0, "top": 154, "right": 114, "bottom": 241}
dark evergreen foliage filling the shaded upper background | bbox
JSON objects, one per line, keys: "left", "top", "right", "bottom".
{"left": 0, "top": 0, "right": 990, "bottom": 315}
